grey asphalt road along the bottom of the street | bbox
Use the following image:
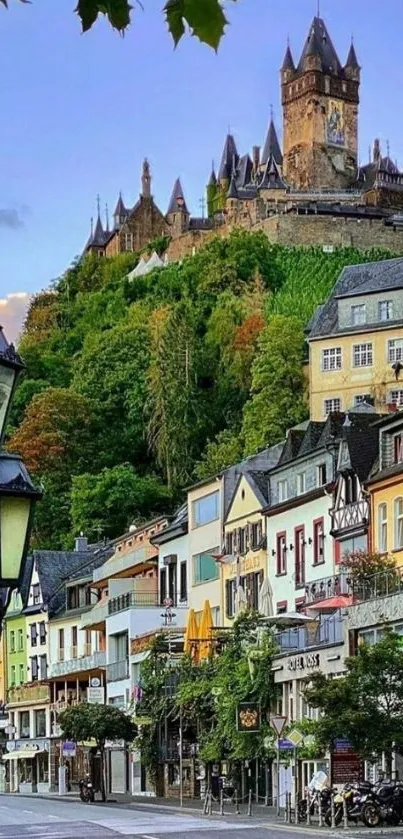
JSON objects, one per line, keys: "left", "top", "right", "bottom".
{"left": 0, "top": 795, "right": 396, "bottom": 839}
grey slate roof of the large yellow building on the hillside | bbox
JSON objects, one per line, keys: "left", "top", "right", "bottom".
{"left": 309, "top": 257, "right": 403, "bottom": 339}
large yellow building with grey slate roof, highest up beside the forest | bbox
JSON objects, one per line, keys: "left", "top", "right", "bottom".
{"left": 307, "top": 258, "right": 403, "bottom": 420}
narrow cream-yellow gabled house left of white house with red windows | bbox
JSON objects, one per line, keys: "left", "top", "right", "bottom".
{"left": 220, "top": 472, "right": 268, "bottom": 626}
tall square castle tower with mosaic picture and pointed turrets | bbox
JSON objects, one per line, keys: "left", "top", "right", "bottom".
{"left": 281, "top": 17, "right": 360, "bottom": 189}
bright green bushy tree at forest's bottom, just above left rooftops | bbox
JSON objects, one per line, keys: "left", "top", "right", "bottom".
{"left": 71, "top": 464, "right": 172, "bottom": 539}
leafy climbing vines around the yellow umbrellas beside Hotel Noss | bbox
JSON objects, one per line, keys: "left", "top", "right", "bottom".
{"left": 138, "top": 612, "right": 275, "bottom": 776}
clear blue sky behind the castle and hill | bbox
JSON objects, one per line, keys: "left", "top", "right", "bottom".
{"left": 0, "top": 0, "right": 403, "bottom": 304}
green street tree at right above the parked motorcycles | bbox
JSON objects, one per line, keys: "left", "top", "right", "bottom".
{"left": 305, "top": 632, "right": 403, "bottom": 777}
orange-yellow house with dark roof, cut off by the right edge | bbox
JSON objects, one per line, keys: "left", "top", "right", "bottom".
{"left": 367, "top": 411, "right": 403, "bottom": 566}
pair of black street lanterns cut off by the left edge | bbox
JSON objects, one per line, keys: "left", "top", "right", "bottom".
{"left": 0, "top": 327, "right": 42, "bottom": 624}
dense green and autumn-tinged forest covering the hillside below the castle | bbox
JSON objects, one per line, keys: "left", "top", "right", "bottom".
{"left": 8, "top": 231, "right": 402, "bottom": 549}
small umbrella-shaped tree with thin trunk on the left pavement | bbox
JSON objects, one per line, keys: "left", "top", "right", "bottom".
{"left": 59, "top": 702, "right": 137, "bottom": 801}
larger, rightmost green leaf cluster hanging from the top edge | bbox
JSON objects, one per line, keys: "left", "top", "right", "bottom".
{"left": 164, "top": 0, "right": 228, "bottom": 50}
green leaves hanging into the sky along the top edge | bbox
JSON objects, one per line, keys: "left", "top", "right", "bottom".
{"left": 0, "top": 0, "right": 235, "bottom": 49}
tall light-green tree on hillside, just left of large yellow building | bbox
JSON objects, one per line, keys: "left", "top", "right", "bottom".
{"left": 242, "top": 315, "right": 308, "bottom": 454}
